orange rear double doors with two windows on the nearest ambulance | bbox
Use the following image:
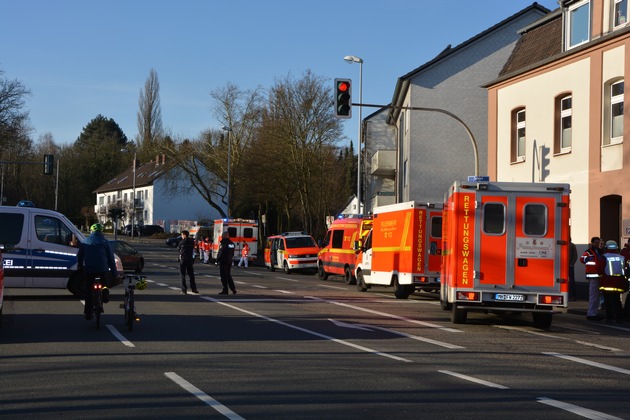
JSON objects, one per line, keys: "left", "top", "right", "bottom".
{"left": 475, "top": 191, "right": 561, "bottom": 292}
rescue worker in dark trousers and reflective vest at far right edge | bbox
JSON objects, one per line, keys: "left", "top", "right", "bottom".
{"left": 599, "top": 241, "right": 628, "bottom": 324}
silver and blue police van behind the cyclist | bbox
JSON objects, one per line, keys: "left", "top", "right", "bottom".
{"left": 0, "top": 206, "right": 123, "bottom": 298}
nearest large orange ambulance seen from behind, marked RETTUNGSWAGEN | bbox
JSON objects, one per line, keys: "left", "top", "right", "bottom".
{"left": 440, "top": 182, "right": 570, "bottom": 328}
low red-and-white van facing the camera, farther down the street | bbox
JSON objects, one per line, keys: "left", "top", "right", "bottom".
{"left": 265, "top": 232, "right": 319, "bottom": 274}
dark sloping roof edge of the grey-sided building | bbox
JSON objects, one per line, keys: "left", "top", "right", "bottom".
{"left": 388, "top": 2, "right": 550, "bottom": 123}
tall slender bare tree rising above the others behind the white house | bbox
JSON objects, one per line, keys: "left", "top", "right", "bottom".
{"left": 137, "top": 69, "right": 164, "bottom": 153}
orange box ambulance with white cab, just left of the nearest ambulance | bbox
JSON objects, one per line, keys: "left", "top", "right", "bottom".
{"left": 355, "top": 201, "right": 442, "bottom": 299}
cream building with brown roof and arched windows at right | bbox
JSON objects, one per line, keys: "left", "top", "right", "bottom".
{"left": 487, "top": 0, "right": 630, "bottom": 248}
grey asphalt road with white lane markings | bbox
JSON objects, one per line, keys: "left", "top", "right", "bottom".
{"left": 0, "top": 243, "right": 630, "bottom": 419}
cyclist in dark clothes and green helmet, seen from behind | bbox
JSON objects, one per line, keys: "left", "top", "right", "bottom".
{"left": 77, "top": 223, "right": 118, "bottom": 320}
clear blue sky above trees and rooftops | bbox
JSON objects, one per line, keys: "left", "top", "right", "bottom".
{"left": 0, "top": 0, "right": 558, "bottom": 150}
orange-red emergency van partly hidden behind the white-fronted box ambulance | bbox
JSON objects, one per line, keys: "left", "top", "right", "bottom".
{"left": 317, "top": 216, "right": 372, "bottom": 284}
